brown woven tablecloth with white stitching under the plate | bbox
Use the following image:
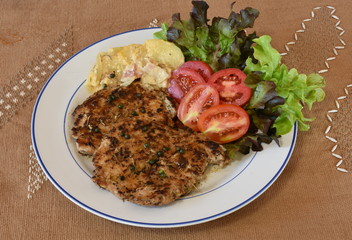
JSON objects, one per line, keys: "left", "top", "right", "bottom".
{"left": 0, "top": 0, "right": 352, "bottom": 240}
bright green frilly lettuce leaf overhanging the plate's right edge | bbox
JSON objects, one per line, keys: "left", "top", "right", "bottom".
{"left": 245, "top": 35, "right": 325, "bottom": 135}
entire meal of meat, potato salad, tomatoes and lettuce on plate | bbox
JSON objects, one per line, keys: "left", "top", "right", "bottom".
{"left": 72, "top": 1, "right": 325, "bottom": 206}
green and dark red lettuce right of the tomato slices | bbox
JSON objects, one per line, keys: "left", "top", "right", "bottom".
{"left": 223, "top": 35, "right": 325, "bottom": 158}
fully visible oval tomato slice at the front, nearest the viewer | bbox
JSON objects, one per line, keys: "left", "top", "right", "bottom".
{"left": 197, "top": 104, "right": 250, "bottom": 144}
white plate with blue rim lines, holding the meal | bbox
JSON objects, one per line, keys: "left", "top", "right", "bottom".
{"left": 32, "top": 28, "right": 297, "bottom": 228}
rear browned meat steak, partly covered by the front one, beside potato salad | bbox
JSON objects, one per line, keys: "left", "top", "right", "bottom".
{"left": 72, "top": 81, "right": 176, "bottom": 155}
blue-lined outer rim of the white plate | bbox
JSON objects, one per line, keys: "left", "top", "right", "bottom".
{"left": 31, "top": 27, "right": 297, "bottom": 227}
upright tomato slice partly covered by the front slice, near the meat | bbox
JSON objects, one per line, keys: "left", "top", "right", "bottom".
{"left": 177, "top": 83, "right": 220, "bottom": 131}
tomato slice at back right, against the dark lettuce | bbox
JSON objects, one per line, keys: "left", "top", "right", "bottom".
{"left": 208, "top": 68, "right": 252, "bottom": 106}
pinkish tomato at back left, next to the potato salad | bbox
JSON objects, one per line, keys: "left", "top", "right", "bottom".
{"left": 168, "top": 68, "right": 205, "bottom": 102}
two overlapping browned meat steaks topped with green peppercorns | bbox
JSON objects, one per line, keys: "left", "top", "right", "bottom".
{"left": 72, "top": 80, "right": 229, "bottom": 205}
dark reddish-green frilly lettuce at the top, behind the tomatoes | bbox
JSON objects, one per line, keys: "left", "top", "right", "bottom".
{"left": 154, "top": 1, "right": 259, "bottom": 71}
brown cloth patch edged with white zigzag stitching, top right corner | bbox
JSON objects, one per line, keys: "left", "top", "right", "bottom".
{"left": 281, "top": 6, "right": 346, "bottom": 74}
